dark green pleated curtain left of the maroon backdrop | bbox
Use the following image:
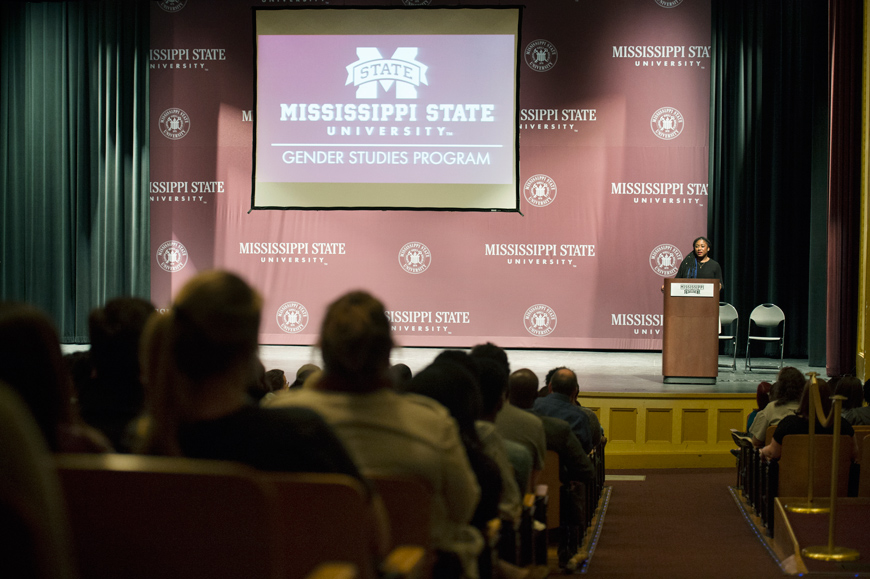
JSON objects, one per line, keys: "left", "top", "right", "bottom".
{"left": 0, "top": 0, "right": 150, "bottom": 342}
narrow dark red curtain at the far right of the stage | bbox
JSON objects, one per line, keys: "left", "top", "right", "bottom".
{"left": 827, "top": 0, "right": 863, "bottom": 376}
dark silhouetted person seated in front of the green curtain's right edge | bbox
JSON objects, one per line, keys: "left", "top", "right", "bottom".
{"left": 78, "top": 297, "right": 155, "bottom": 452}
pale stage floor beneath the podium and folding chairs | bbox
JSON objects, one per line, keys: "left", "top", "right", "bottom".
{"left": 260, "top": 346, "right": 825, "bottom": 394}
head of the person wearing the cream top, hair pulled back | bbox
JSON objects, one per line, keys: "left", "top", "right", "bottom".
{"left": 320, "top": 291, "right": 393, "bottom": 391}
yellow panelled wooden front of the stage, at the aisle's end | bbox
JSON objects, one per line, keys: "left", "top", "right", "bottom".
{"left": 579, "top": 392, "right": 756, "bottom": 470}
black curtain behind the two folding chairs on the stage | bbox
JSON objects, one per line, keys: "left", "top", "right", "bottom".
{"left": 707, "top": 0, "right": 829, "bottom": 366}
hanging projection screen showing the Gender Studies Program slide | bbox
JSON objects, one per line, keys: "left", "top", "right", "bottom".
{"left": 253, "top": 9, "right": 518, "bottom": 211}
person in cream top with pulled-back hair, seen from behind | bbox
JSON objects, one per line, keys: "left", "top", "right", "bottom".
{"left": 270, "top": 291, "right": 483, "bottom": 577}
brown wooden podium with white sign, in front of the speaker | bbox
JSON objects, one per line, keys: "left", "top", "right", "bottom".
{"left": 662, "top": 279, "right": 719, "bottom": 384}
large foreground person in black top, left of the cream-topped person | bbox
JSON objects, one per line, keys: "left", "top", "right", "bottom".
{"left": 140, "top": 271, "right": 360, "bottom": 478}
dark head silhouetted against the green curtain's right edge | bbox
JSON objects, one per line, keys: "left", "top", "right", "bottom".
{"left": 88, "top": 297, "right": 155, "bottom": 386}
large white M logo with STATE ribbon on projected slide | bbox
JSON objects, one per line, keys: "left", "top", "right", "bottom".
{"left": 344, "top": 47, "right": 429, "bottom": 99}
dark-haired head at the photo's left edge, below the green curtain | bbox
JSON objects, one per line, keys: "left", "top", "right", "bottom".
{"left": 0, "top": 302, "right": 72, "bottom": 450}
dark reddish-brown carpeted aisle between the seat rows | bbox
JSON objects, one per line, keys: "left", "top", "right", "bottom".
{"left": 551, "top": 469, "right": 783, "bottom": 579}
